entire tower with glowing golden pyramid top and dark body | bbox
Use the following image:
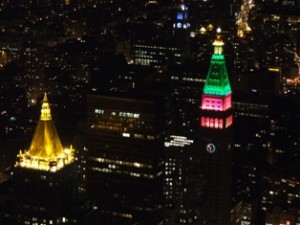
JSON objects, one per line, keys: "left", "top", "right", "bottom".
{"left": 11, "top": 94, "right": 78, "bottom": 224}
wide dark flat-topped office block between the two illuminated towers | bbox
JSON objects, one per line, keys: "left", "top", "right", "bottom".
{"left": 86, "top": 88, "right": 168, "bottom": 225}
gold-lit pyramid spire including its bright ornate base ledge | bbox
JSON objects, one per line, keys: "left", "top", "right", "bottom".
{"left": 17, "top": 93, "right": 74, "bottom": 171}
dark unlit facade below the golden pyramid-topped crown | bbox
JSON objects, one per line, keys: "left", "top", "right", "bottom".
{"left": 11, "top": 164, "right": 78, "bottom": 224}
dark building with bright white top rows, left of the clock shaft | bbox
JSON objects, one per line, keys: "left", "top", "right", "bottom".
{"left": 164, "top": 135, "right": 206, "bottom": 225}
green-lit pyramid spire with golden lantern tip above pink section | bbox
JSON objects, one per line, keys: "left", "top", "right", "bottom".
{"left": 203, "top": 35, "right": 231, "bottom": 96}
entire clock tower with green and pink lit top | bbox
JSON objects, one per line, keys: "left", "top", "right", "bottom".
{"left": 199, "top": 36, "right": 233, "bottom": 225}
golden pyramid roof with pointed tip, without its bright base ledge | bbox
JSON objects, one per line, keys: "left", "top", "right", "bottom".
{"left": 27, "top": 93, "right": 64, "bottom": 159}
